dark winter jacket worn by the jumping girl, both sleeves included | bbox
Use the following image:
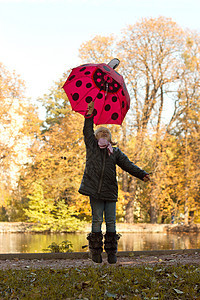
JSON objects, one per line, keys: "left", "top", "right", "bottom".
{"left": 79, "top": 117, "right": 148, "bottom": 201}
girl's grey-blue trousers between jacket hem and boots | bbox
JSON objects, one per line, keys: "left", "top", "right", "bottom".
{"left": 90, "top": 197, "right": 116, "bottom": 232}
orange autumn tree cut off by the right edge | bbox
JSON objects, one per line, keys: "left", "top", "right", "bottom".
{"left": 167, "top": 31, "right": 200, "bottom": 224}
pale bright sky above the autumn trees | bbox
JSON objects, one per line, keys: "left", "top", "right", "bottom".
{"left": 0, "top": 0, "right": 200, "bottom": 101}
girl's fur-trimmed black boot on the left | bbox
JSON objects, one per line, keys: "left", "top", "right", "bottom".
{"left": 87, "top": 232, "right": 103, "bottom": 263}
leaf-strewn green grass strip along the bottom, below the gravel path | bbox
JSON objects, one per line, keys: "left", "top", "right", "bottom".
{"left": 0, "top": 265, "right": 200, "bottom": 300}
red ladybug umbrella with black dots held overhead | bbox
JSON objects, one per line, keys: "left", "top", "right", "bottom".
{"left": 63, "top": 60, "right": 130, "bottom": 125}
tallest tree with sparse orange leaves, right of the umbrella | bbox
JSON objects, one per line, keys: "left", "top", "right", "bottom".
{"left": 115, "top": 17, "right": 188, "bottom": 223}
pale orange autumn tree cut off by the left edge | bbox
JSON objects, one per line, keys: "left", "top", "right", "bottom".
{"left": 0, "top": 63, "right": 36, "bottom": 218}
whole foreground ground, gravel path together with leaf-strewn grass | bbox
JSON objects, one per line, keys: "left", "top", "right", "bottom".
{"left": 0, "top": 251, "right": 200, "bottom": 300}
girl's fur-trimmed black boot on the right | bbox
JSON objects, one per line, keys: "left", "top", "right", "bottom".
{"left": 104, "top": 232, "right": 120, "bottom": 264}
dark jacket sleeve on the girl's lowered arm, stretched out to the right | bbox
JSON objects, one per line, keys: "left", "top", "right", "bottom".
{"left": 116, "top": 149, "right": 148, "bottom": 180}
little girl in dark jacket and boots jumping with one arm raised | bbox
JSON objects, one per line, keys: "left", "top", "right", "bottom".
{"left": 79, "top": 102, "right": 150, "bottom": 264}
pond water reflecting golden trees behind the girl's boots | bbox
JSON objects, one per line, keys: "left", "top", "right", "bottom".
{"left": 0, "top": 233, "right": 200, "bottom": 253}
